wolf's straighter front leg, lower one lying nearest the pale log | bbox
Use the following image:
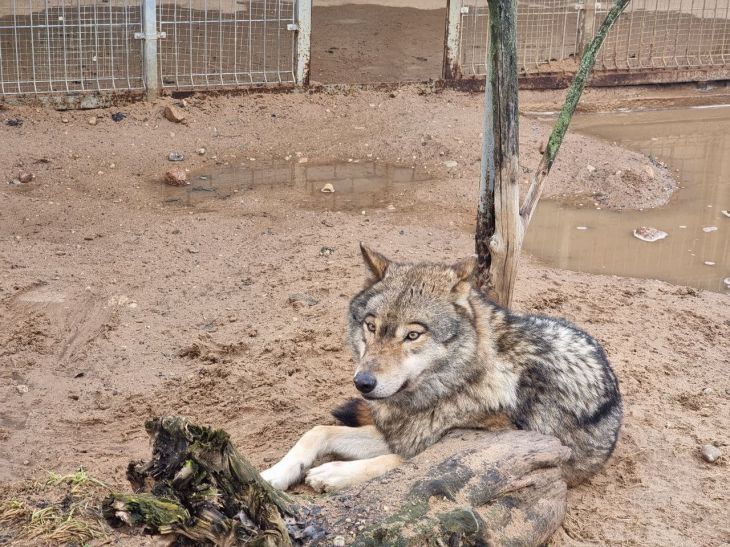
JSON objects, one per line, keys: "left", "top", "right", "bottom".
{"left": 305, "top": 454, "right": 403, "bottom": 492}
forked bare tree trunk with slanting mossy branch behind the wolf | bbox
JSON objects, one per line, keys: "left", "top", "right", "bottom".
{"left": 476, "top": 0, "right": 630, "bottom": 306}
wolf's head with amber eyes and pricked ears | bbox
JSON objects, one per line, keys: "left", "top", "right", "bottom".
{"left": 348, "top": 245, "right": 477, "bottom": 406}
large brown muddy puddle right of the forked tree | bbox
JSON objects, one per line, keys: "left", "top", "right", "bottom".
{"left": 525, "top": 107, "right": 730, "bottom": 293}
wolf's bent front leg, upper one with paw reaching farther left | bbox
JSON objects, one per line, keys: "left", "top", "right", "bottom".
{"left": 261, "top": 425, "right": 390, "bottom": 490}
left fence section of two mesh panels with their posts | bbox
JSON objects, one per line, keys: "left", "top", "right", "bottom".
{"left": 0, "top": 0, "right": 311, "bottom": 101}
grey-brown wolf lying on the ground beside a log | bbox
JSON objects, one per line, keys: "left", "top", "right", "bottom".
{"left": 262, "top": 245, "right": 623, "bottom": 491}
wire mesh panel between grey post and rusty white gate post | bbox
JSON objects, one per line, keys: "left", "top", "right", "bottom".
{"left": 158, "top": 0, "right": 297, "bottom": 89}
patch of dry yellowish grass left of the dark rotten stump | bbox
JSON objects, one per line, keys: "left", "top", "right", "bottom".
{"left": 0, "top": 468, "right": 110, "bottom": 545}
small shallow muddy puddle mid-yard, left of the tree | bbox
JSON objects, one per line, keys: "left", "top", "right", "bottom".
{"left": 163, "top": 160, "right": 430, "bottom": 211}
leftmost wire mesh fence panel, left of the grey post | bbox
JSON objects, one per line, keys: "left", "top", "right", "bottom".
{"left": 0, "top": 0, "right": 144, "bottom": 96}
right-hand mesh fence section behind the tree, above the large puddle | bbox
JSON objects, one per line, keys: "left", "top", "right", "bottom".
{"left": 444, "top": 0, "right": 730, "bottom": 87}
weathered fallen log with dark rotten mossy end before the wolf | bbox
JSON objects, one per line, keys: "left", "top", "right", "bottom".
{"left": 103, "top": 417, "right": 570, "bottom": 547}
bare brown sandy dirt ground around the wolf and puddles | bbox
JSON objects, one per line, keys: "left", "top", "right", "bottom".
{"left": 0, "top": 86, "right": 730, "bottom": 545}
